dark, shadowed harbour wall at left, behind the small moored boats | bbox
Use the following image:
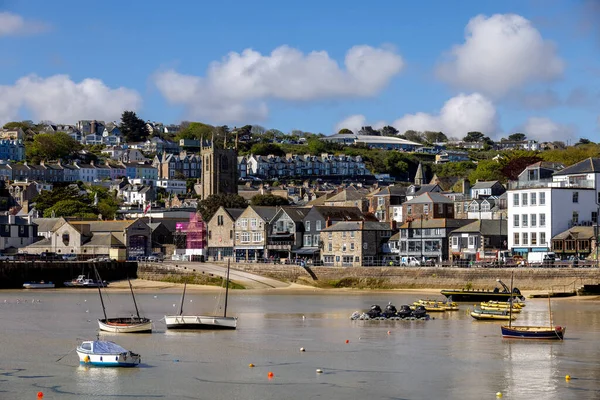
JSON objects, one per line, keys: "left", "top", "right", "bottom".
{"left": 0, "top": 261, "right": 137, "bottom": 289}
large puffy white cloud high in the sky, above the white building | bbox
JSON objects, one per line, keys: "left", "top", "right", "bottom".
{"left": 437, "top": 14, "right": 565, "bottom": 97}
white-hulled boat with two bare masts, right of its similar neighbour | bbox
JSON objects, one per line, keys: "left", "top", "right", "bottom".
{"left": 165, "top": 261, "right": 237, "bottom": 329}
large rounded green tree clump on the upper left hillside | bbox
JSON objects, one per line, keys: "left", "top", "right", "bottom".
{"left": 25, "top": 132, "right": 83, "bottom": 164}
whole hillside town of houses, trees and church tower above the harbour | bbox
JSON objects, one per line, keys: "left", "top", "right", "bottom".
{"left": 0, "top": 112, "right": 600, "bottom": 267}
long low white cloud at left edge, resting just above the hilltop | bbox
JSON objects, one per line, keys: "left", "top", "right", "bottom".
{"left": 0, "top": 75, "right": 142, "bottom": 123}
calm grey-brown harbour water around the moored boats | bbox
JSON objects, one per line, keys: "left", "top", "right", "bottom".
{"left": 0, "top": 290, "right": 600, "bottom": 400}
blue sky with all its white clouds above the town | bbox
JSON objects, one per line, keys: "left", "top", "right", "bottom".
{"left": 0, "top": 0, "right": 600, "bottom": 141}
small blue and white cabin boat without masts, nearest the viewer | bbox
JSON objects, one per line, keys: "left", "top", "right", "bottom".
{"left": 77, "top": 340, "right": 142, "bottom": 367}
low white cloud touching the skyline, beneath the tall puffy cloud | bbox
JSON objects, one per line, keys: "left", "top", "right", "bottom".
{"left": 392, "top": 93, "right": 498, "bottom": 138}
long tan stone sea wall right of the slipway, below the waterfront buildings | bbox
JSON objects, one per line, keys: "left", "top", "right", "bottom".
{"left": 226, "top": 264, "right": 600, "bottom": 292}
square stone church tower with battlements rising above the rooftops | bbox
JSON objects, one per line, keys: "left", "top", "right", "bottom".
{"left": 199, "top": 139, "right": 238, "bottom": 200}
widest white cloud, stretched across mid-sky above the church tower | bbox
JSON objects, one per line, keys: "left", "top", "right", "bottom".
{"left": 153, "top": 46, "right": 404, "bottom": 123}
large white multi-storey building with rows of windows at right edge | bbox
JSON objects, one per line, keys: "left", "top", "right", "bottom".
{"left": 508, "top": 158, "right": 600, "bottom": 254}
